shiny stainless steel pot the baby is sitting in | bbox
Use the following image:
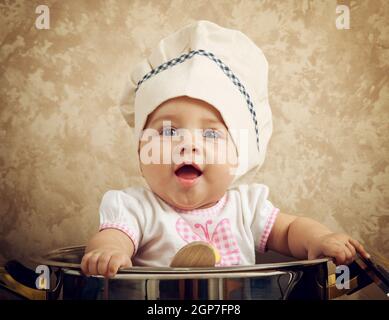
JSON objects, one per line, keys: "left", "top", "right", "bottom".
{"left": 0, "top": 246, "right": 389, "bottom": 300}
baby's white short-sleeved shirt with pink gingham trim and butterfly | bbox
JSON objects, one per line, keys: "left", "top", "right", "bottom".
{"left": 100, "top": 183, "right": 279, "bottom": 267}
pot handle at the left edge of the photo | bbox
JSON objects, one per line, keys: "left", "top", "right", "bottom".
{"left": 0, "top": 260, "right": 63, "bottom": 300}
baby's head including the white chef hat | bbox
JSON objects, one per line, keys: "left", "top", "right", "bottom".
{"left": 120, "top": 21, "right": 272, "bottom": 209}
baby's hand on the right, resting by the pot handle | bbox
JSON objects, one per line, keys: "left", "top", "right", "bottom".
{"left": 308, "top": 233, "right": 370, "bottom": 265}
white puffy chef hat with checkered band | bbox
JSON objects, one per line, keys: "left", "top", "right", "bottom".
{"left": 120, "top": 20, "right": 272, "bottom": 182}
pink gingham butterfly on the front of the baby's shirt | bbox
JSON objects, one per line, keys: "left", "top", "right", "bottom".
{"left": 176, "top": 218, "right": 241, "bottom": 266}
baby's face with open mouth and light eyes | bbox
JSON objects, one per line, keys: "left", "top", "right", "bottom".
{"left": 139, "top": 96, "right": 237, "bottom": 210}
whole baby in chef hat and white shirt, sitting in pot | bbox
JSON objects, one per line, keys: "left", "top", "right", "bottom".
{"left": 81, "top": 21, "right": 369, "bottom": 277}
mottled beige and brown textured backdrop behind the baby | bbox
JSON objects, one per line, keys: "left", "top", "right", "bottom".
{"left": 0, "top": 0, "right": 389, "bottom": 268}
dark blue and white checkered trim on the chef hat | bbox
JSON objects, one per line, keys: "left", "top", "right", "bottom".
{"left": 135, "top": 49, "right": 259, "bottom": 151}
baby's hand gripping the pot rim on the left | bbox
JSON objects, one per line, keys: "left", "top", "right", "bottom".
{"left": 81, "top": 247, "right": 132, "bottom": 278}
